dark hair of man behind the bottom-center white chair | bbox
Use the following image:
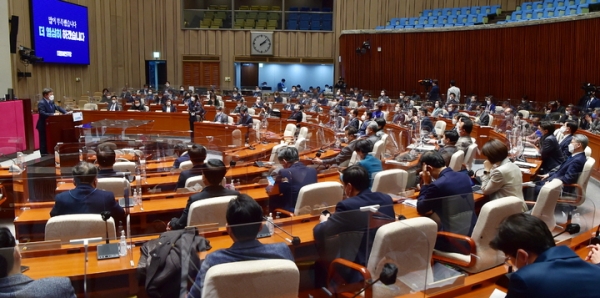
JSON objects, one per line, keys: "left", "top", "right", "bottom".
{"left": 225, "top": 194, "right": 262, "bottom": 241}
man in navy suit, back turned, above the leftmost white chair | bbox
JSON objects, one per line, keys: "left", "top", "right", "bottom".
{"left": 50, "top": 161, "right": 125, "bottom": 223}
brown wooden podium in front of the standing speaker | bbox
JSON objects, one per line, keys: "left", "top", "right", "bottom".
{"left": 46, "top": 114, "right": 81, "bottom": 154}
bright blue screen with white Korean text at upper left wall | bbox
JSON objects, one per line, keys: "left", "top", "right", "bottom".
{"left": 30, "top": 0, "right": 90, "bottom": 65}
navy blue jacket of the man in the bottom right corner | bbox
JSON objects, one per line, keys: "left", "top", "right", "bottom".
{"left": 506, "top": 246, "right": 600, "bottom": 298}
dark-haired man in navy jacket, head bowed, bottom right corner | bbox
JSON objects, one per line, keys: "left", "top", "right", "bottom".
{"left": 490, "top": 213, "right": 600, "bottom": 298}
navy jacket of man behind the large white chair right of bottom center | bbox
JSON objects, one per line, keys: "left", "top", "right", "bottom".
{"left": 313, "top": 189, "right": 396, "bottom": 265}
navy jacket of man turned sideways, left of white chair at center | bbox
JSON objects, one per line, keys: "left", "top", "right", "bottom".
{"left": 276, "top": 162, "right": 317, "bottom": 212}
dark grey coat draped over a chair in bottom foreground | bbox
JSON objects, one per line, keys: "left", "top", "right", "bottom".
{"left": 137, "top": 229, "right": 211, "bottom": 297}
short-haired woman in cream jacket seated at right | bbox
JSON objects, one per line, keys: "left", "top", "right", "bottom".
{"left": 481, "top": 139, "right": 527, "bottom": 211}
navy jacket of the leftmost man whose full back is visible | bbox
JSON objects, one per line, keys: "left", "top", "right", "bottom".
{"left": 50, "top": 183, "right": 125, "bottom": 223}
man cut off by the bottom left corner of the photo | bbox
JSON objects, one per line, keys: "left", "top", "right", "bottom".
{"left": 0, "top": 227, "right": 76, "bottom": 298}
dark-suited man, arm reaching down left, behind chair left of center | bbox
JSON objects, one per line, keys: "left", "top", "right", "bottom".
{"left": 167, "top": 159, "right": 240, "bottom": 231}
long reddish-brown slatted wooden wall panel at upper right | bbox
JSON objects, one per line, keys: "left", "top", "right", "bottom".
{"left": 340, "top": 18, "right": 600, "bottom": 103}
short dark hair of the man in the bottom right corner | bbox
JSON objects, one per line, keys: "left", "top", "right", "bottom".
{"left": 490, "top": 213, "right": 555, "bottom": 256}
